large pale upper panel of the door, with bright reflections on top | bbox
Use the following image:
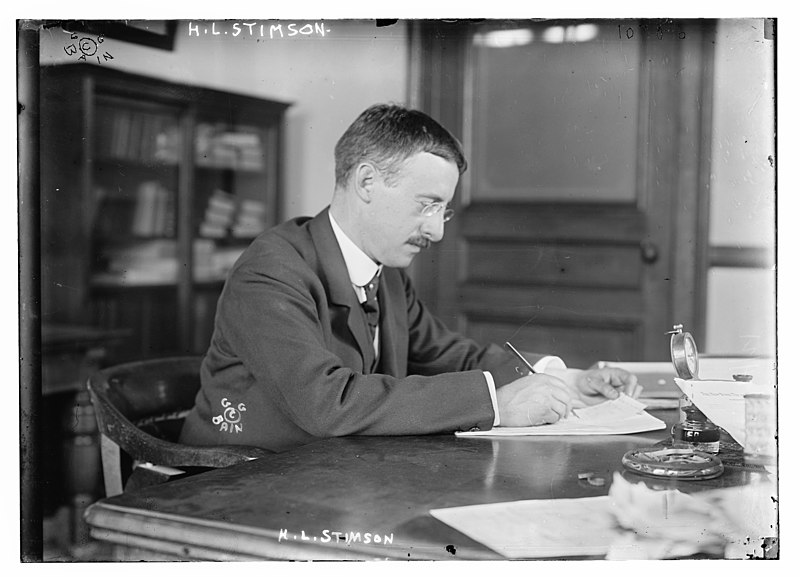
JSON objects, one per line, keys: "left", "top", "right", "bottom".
{"left": 465, "top": 21, "right": 641, "bottom": 203}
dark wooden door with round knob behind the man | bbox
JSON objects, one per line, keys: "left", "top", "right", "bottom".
{"left": 412, "top": 21, "right": 712, "bottom": 366}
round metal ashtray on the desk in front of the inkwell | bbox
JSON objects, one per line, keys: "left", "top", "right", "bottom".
{"left": 622, "top": 447, "right": 725, "bottom": 481}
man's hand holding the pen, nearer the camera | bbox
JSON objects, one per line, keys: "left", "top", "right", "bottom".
{"left": 497, "top": 374, "right": 572, "bottom": 427}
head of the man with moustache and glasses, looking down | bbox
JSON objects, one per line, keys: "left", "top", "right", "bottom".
{"left": 333, "top": 104, "right": 467, "bottom": 267}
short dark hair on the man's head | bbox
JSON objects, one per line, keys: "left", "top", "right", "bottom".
{"left": 334, "top": 104, "right": 467, "bottom": 186}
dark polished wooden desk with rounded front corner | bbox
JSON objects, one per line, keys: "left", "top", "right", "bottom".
{"left": 86, "top": 412, "right": 761, "bottom": 560}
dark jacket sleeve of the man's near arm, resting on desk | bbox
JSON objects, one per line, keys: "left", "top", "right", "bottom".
{"left": 212, "top": 252, "right": 494, "bottom": 437}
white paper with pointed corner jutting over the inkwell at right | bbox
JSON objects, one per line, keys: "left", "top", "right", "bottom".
{"left": 675, "top": 377, "right": 775, "bottom": 447}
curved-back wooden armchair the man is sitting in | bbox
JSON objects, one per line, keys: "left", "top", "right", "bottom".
{"left": 87, "top": 357, "right": 272, "bottom": 497}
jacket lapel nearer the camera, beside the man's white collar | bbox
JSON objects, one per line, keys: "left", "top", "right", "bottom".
{"left": 309, "top": 208, "right": 383, "bottom": 373}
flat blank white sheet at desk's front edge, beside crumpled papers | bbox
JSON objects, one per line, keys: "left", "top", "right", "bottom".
{"left": 431, "top": 497, "right": 615, "bottom": 559}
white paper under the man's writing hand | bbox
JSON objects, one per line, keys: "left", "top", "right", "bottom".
{"left": 456, "top": 395, "right": 666, "bottom": 437}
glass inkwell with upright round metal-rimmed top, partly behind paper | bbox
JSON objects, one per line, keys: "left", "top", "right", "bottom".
{"left": 667, "top": 325, "right": 720, "bottom": 454}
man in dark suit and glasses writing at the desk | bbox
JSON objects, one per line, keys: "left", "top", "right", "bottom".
{"left": 182, "top": 105, "right": 636, "bottom": 451}
